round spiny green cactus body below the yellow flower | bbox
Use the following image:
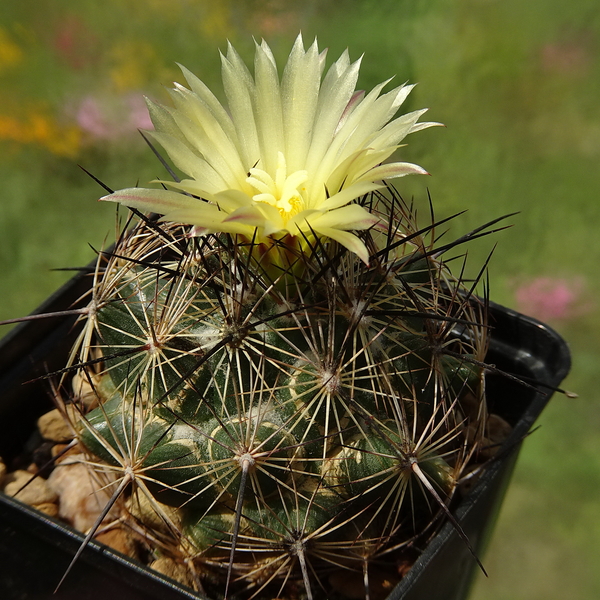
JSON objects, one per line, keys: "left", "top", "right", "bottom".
{"left": 68, "top": 189, "right": 486, "bottom": 598}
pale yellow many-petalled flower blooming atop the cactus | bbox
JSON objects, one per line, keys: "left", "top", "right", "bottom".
{"left": 102, "top": 36, "right": 437, "bottom": 262}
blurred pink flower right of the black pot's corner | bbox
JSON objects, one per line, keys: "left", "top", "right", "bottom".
{"left": 515, "top": 277, "right": 590, "bottom": 321}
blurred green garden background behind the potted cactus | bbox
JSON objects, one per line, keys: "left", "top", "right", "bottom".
{"left": 0, "top": 0, "right": 600, "bottom": 600}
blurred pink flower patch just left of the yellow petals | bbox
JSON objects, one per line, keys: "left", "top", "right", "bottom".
{"left": 75, "top": 94, "right": 152, "bottom": 140}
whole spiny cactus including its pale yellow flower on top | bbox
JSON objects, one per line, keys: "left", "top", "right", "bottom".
{"left": 55, "top": 38, "right": 496, "bottom": 599}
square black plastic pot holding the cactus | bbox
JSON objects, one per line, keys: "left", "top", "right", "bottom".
{"left": 0, "top": 274, "right": 570, "bottom": 600}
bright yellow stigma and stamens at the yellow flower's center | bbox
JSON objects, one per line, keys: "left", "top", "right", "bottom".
{"left": 246, "top": 152, "right": 308, "bottom": 218}
